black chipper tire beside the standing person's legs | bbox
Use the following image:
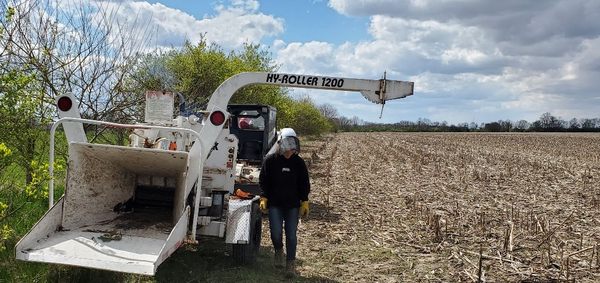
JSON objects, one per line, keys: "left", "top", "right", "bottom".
{"left": 232, "top": 202, "right": 262, "bottom": 264}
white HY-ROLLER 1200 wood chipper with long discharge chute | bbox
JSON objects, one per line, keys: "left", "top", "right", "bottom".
{"left": 16, "top": 72, "right": 413, "bottom": 275}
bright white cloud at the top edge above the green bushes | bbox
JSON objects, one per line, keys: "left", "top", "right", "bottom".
{"left": 90, "top": 0, "right": 283, "bottom": 49}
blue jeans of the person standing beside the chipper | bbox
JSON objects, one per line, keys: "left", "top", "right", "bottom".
{"left": 269, "top": 206, "right": 298, "bottom": 260}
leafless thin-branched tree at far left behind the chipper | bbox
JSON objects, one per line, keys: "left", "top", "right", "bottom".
{"left": 0, "top": 0, "right": 155, "bottom": 182}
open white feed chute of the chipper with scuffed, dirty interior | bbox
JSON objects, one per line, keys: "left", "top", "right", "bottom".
{"left": 16, "top": 142, "right": 195, "bottom": 275}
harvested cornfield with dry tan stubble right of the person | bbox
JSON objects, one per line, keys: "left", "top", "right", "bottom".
{"left": 284, "top": 133, "right": 600, "bottom": 282}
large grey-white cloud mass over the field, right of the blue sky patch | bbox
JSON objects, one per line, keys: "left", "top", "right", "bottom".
{"left": 266, "top": 0, "right": 600, "bottom": 122}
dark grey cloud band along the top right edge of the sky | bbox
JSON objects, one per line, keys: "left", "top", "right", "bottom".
{"left": 329, "top": 0, "right": 600, "bottom": 55}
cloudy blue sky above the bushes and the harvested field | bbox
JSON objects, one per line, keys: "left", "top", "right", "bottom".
{"left": 91, "top": 0, "right": 600, "bottom": 123}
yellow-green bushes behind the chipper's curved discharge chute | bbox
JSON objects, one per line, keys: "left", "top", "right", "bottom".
{"left": 128, "top": 40, "right": 332, "bottom": 138}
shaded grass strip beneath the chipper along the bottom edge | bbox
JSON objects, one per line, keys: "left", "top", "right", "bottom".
{"left": 0, "top": 235, "right": 335, "bottom": 283}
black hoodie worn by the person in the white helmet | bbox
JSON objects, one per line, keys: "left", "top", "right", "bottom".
{"left": 260, "top": 153, "right": 310, "bottom": 208}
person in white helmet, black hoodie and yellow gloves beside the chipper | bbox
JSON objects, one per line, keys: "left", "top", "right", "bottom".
{"left": 259, "top": 128, "right": 310, "bottom": 275}
